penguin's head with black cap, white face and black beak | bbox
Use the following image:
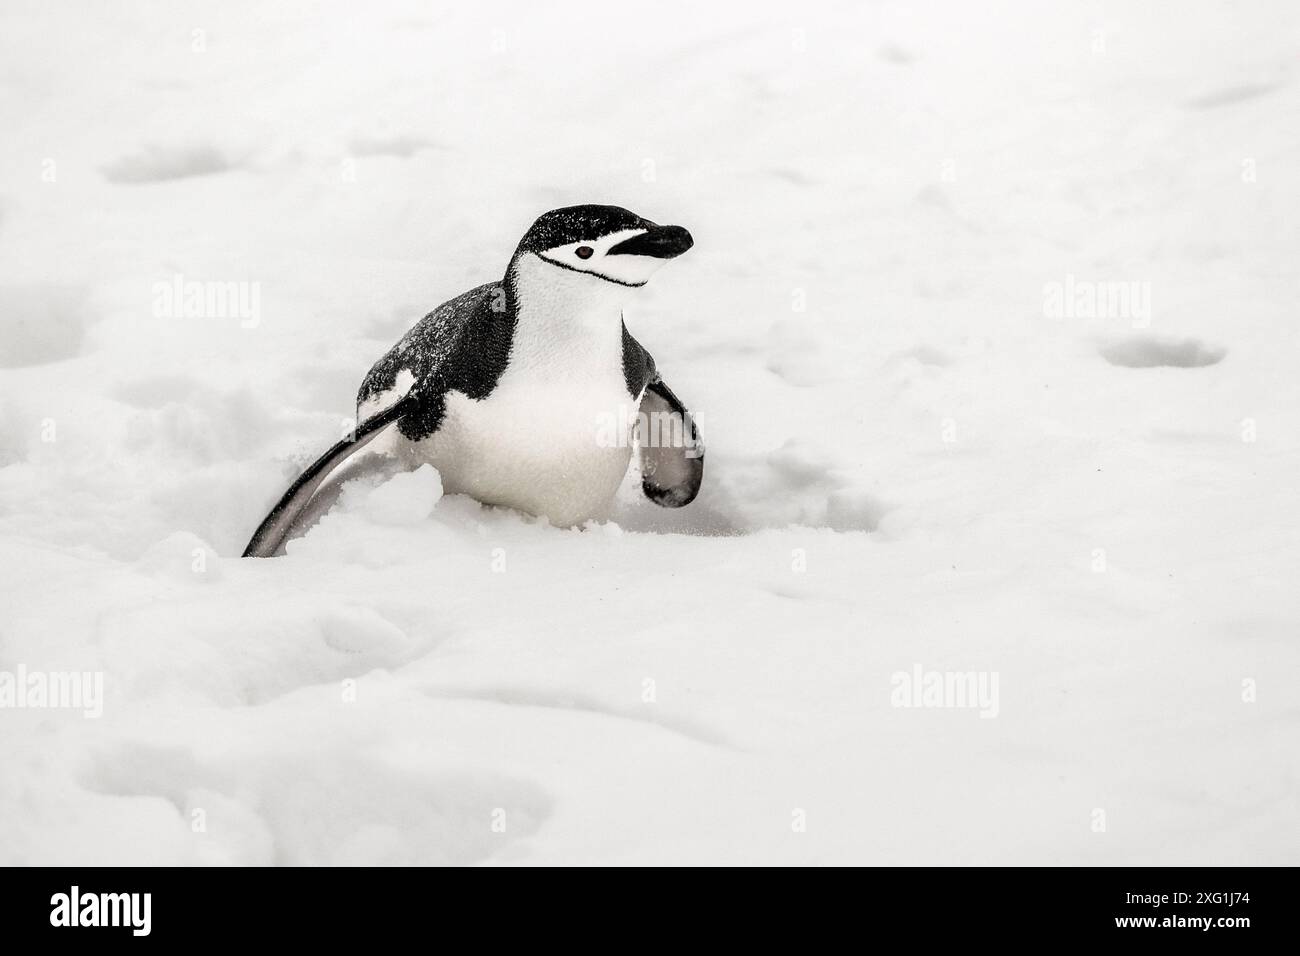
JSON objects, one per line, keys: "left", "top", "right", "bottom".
{"left": 515, "top": 206, "right": 694, "bottom": 286}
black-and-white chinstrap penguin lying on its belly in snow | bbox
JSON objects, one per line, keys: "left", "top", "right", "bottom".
{"left": 244, "top": 206, "right": 705, "bottom": 557}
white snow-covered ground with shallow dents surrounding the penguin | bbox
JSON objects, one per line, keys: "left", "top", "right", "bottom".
{"left": 0, "top": 0, "right": 1300, "bottom": 864}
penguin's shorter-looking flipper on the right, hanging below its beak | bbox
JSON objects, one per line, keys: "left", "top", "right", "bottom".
{"left": 637, "top": 375, "right": 705, "bottom": 507}
